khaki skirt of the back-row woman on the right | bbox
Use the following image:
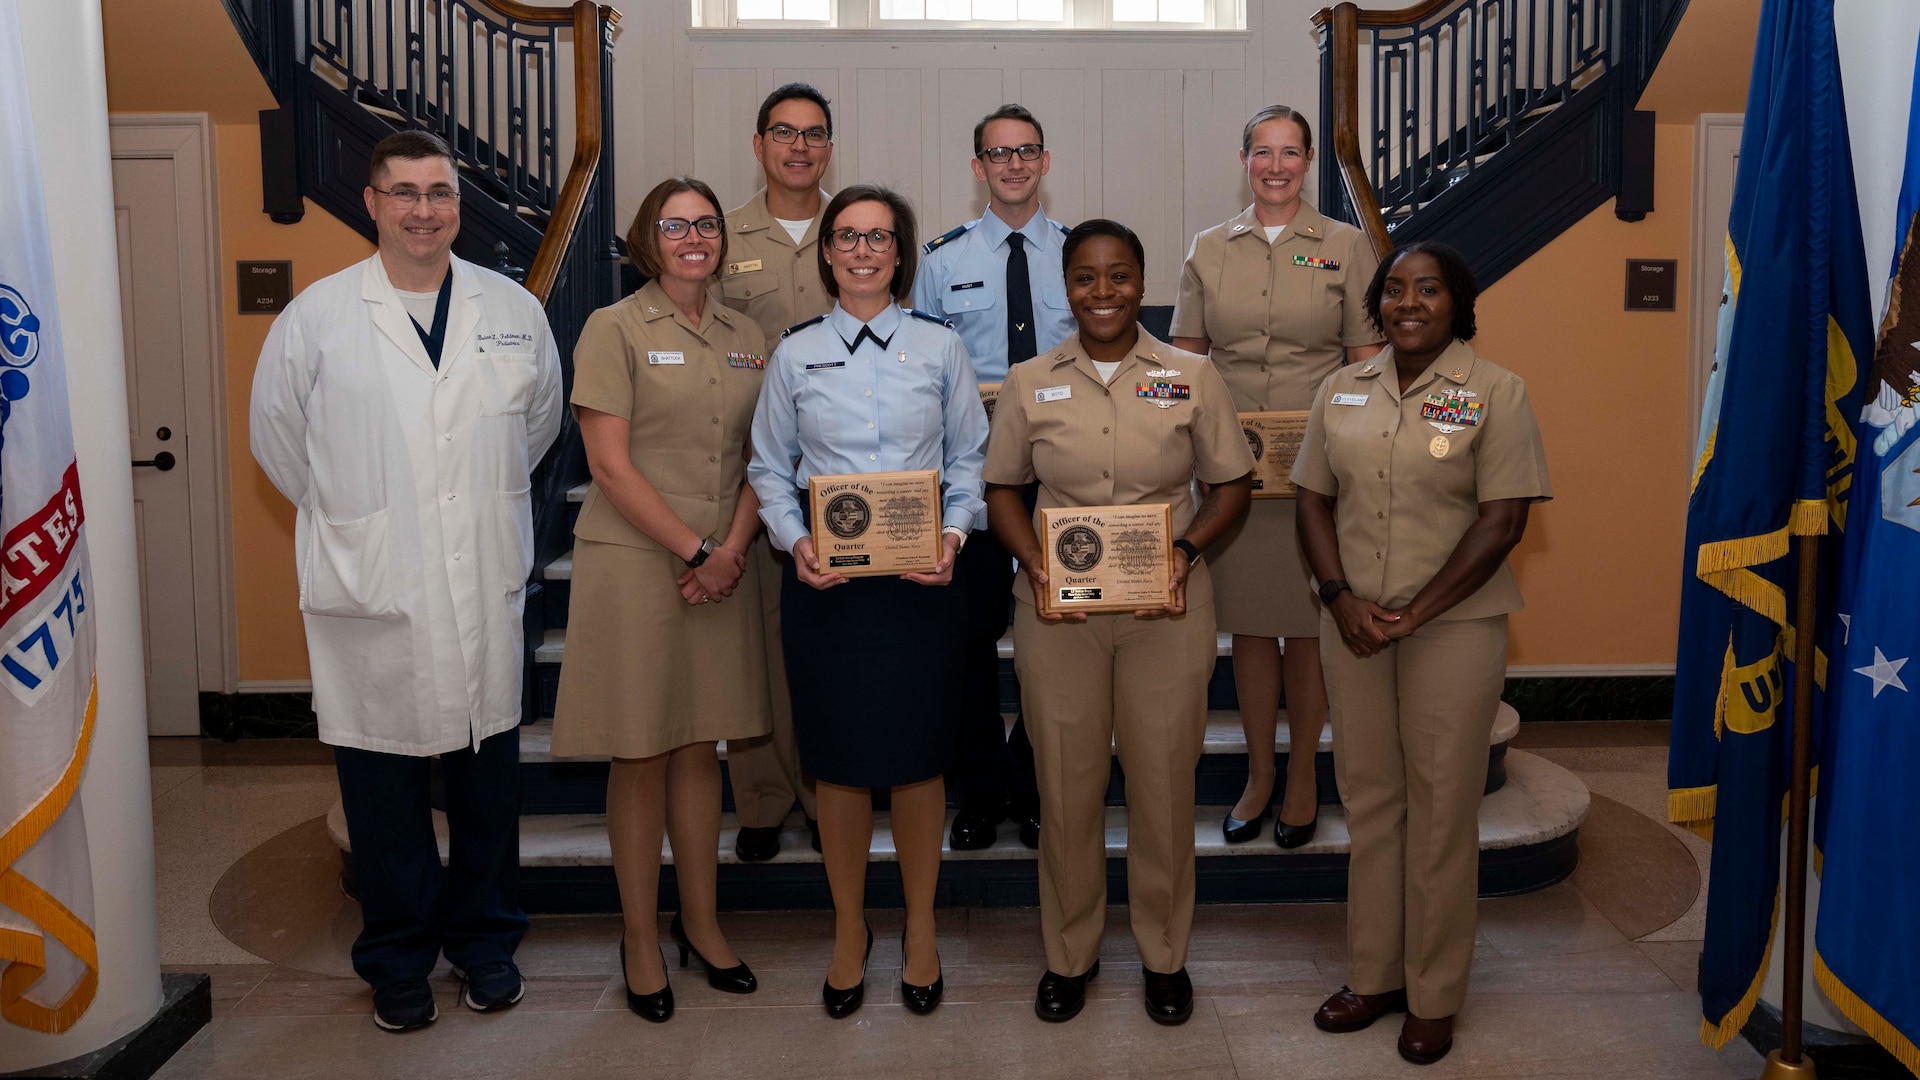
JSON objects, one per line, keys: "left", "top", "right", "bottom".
{"left": 1205, "top": 500, "right": 1319, "bottom": 648}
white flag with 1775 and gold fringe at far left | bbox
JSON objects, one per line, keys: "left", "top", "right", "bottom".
{"left": 0, "top": 0, "right": 100, "bottom": 1032}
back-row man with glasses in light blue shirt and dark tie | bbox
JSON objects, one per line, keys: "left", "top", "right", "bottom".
{"left": 912, "top": 104, "right": 1073, "bottom": 851}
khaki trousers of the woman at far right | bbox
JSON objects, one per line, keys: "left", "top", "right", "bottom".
{"left": 1321, "top": 613, "right": 1507, "bottom": 1020}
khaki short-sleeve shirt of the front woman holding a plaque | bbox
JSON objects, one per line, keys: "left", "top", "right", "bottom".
{"left": 983, "top": 331, "right": 1254, "bottom": 607}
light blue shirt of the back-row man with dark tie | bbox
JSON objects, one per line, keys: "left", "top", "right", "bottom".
{"left": 912, "top": 209, "right": 1079, "bottom": 382}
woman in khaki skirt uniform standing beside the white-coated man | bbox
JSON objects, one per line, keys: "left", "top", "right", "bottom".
{"left": 553, "top": 177, "right": 768, "bottom": 1020}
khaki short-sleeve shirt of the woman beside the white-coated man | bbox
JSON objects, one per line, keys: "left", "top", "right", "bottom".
{"left": 572, "top": 281, "right": 766, "bottom": 548}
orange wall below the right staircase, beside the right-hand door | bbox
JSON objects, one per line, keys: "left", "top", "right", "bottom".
{"left": 1473, "top": 125, "right": 1693, "bottom": 665}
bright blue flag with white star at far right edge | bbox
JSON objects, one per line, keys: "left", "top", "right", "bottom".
{"left": 1812, "top": 23, "right": 1920, "bottom": 1070}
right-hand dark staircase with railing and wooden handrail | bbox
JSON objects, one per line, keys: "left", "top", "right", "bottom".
{"left": 1313, "top": 0, "right": 1686, "bottom": 288}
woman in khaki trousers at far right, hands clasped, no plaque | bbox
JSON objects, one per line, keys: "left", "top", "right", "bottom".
{"left": 1292, "top": 242, "right": 1553, "bottom": 1065}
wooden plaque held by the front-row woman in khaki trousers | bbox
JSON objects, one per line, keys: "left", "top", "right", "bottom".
{"left": 1037, "top": 503, "right": 1173, "bottom": 615}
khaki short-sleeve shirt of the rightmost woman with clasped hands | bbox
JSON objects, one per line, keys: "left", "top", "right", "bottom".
{"left": 1292, "top": 342, "right": 1553, "bottom": 619}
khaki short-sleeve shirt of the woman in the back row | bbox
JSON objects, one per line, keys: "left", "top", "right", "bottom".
{"left": 1173, "top": 202, "right": 1380, "bottom": 413}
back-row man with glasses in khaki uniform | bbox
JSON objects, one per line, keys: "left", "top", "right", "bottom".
{"left": 720, "top": 83, "right": 833, "bottom": 863}
